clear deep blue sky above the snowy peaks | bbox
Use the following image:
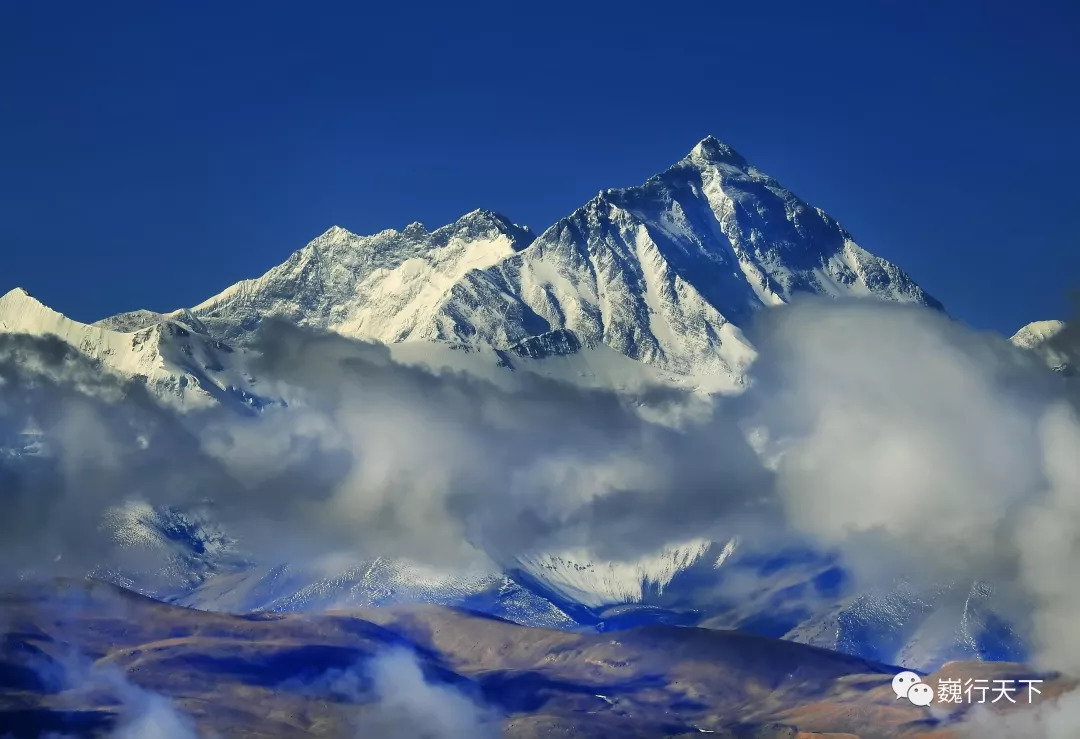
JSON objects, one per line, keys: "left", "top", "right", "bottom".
{"left": 0, "top": 0, "right": 1080, "bottom": 332}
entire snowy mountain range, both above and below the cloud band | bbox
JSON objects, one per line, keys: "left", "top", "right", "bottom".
{"left": 0, "top": 136, "right": 1066, "bottom": 666}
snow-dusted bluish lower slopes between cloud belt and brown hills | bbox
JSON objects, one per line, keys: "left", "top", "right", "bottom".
{"left": 93, "top": 506, "right": 1026, "bottom": 670}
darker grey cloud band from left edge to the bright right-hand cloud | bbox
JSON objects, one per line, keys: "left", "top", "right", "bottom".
{"left": 0, "top": 322, "right": 768, "bottom": 567}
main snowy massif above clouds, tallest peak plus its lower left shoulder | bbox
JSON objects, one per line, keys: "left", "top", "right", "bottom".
{"left": 168, "top": 137, "right": 940, "bottom": 381}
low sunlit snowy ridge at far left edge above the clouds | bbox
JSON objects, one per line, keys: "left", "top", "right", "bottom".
{"left": 0, "top": 287, "right": 255, "bottom": 408}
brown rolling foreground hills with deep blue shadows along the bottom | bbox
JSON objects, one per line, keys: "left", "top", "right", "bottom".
{"left": 0, "top": 581, "right": 1068, "bottom": 739}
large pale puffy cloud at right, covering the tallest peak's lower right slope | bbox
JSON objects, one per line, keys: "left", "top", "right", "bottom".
{"left": 747, "top": 301, "right": 1080, "bottom": 671}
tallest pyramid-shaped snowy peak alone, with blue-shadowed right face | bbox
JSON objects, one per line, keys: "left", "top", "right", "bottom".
{"left": 425, "top": 137, "right": 937, "bottom": 376}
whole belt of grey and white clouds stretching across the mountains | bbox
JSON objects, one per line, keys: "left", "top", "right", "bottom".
{"left": 6, "top": 300, "right": 1080, "bottom": 672}
